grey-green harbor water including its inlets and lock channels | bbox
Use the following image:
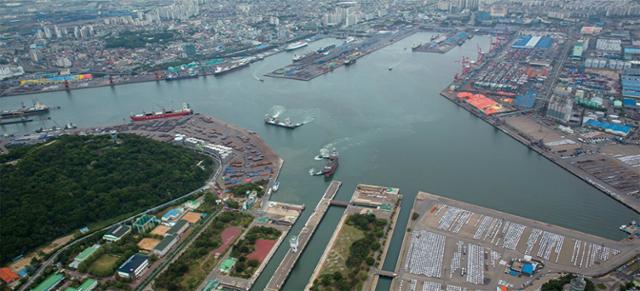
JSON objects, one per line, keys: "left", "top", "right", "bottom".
{"left": 0, "top": 33, "right": 638, "bottom": 290}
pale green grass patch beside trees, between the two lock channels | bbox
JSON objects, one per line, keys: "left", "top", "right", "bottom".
{"left": 320, "top": 223, "right": 364, "bottom": 274}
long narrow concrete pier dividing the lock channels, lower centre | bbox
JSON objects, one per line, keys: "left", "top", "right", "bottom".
{"left": 265, "top": 181, "right": 342, "bottom": 291}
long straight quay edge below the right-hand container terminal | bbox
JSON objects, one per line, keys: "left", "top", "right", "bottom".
{"left": 440, "top": 87, "right": 640, "bottom": 214}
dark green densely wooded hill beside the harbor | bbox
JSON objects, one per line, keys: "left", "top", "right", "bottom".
{"left": 0, "top": 134, "right": 215, "bottom": 263}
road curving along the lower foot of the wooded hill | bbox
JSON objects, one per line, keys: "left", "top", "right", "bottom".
{"left": 19, "top": 155, "right": 223, "bottom": 290}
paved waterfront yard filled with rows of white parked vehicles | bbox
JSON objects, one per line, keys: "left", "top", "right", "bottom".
{"left": 392, "top": 192, "right": 640, "bottom": 290}
